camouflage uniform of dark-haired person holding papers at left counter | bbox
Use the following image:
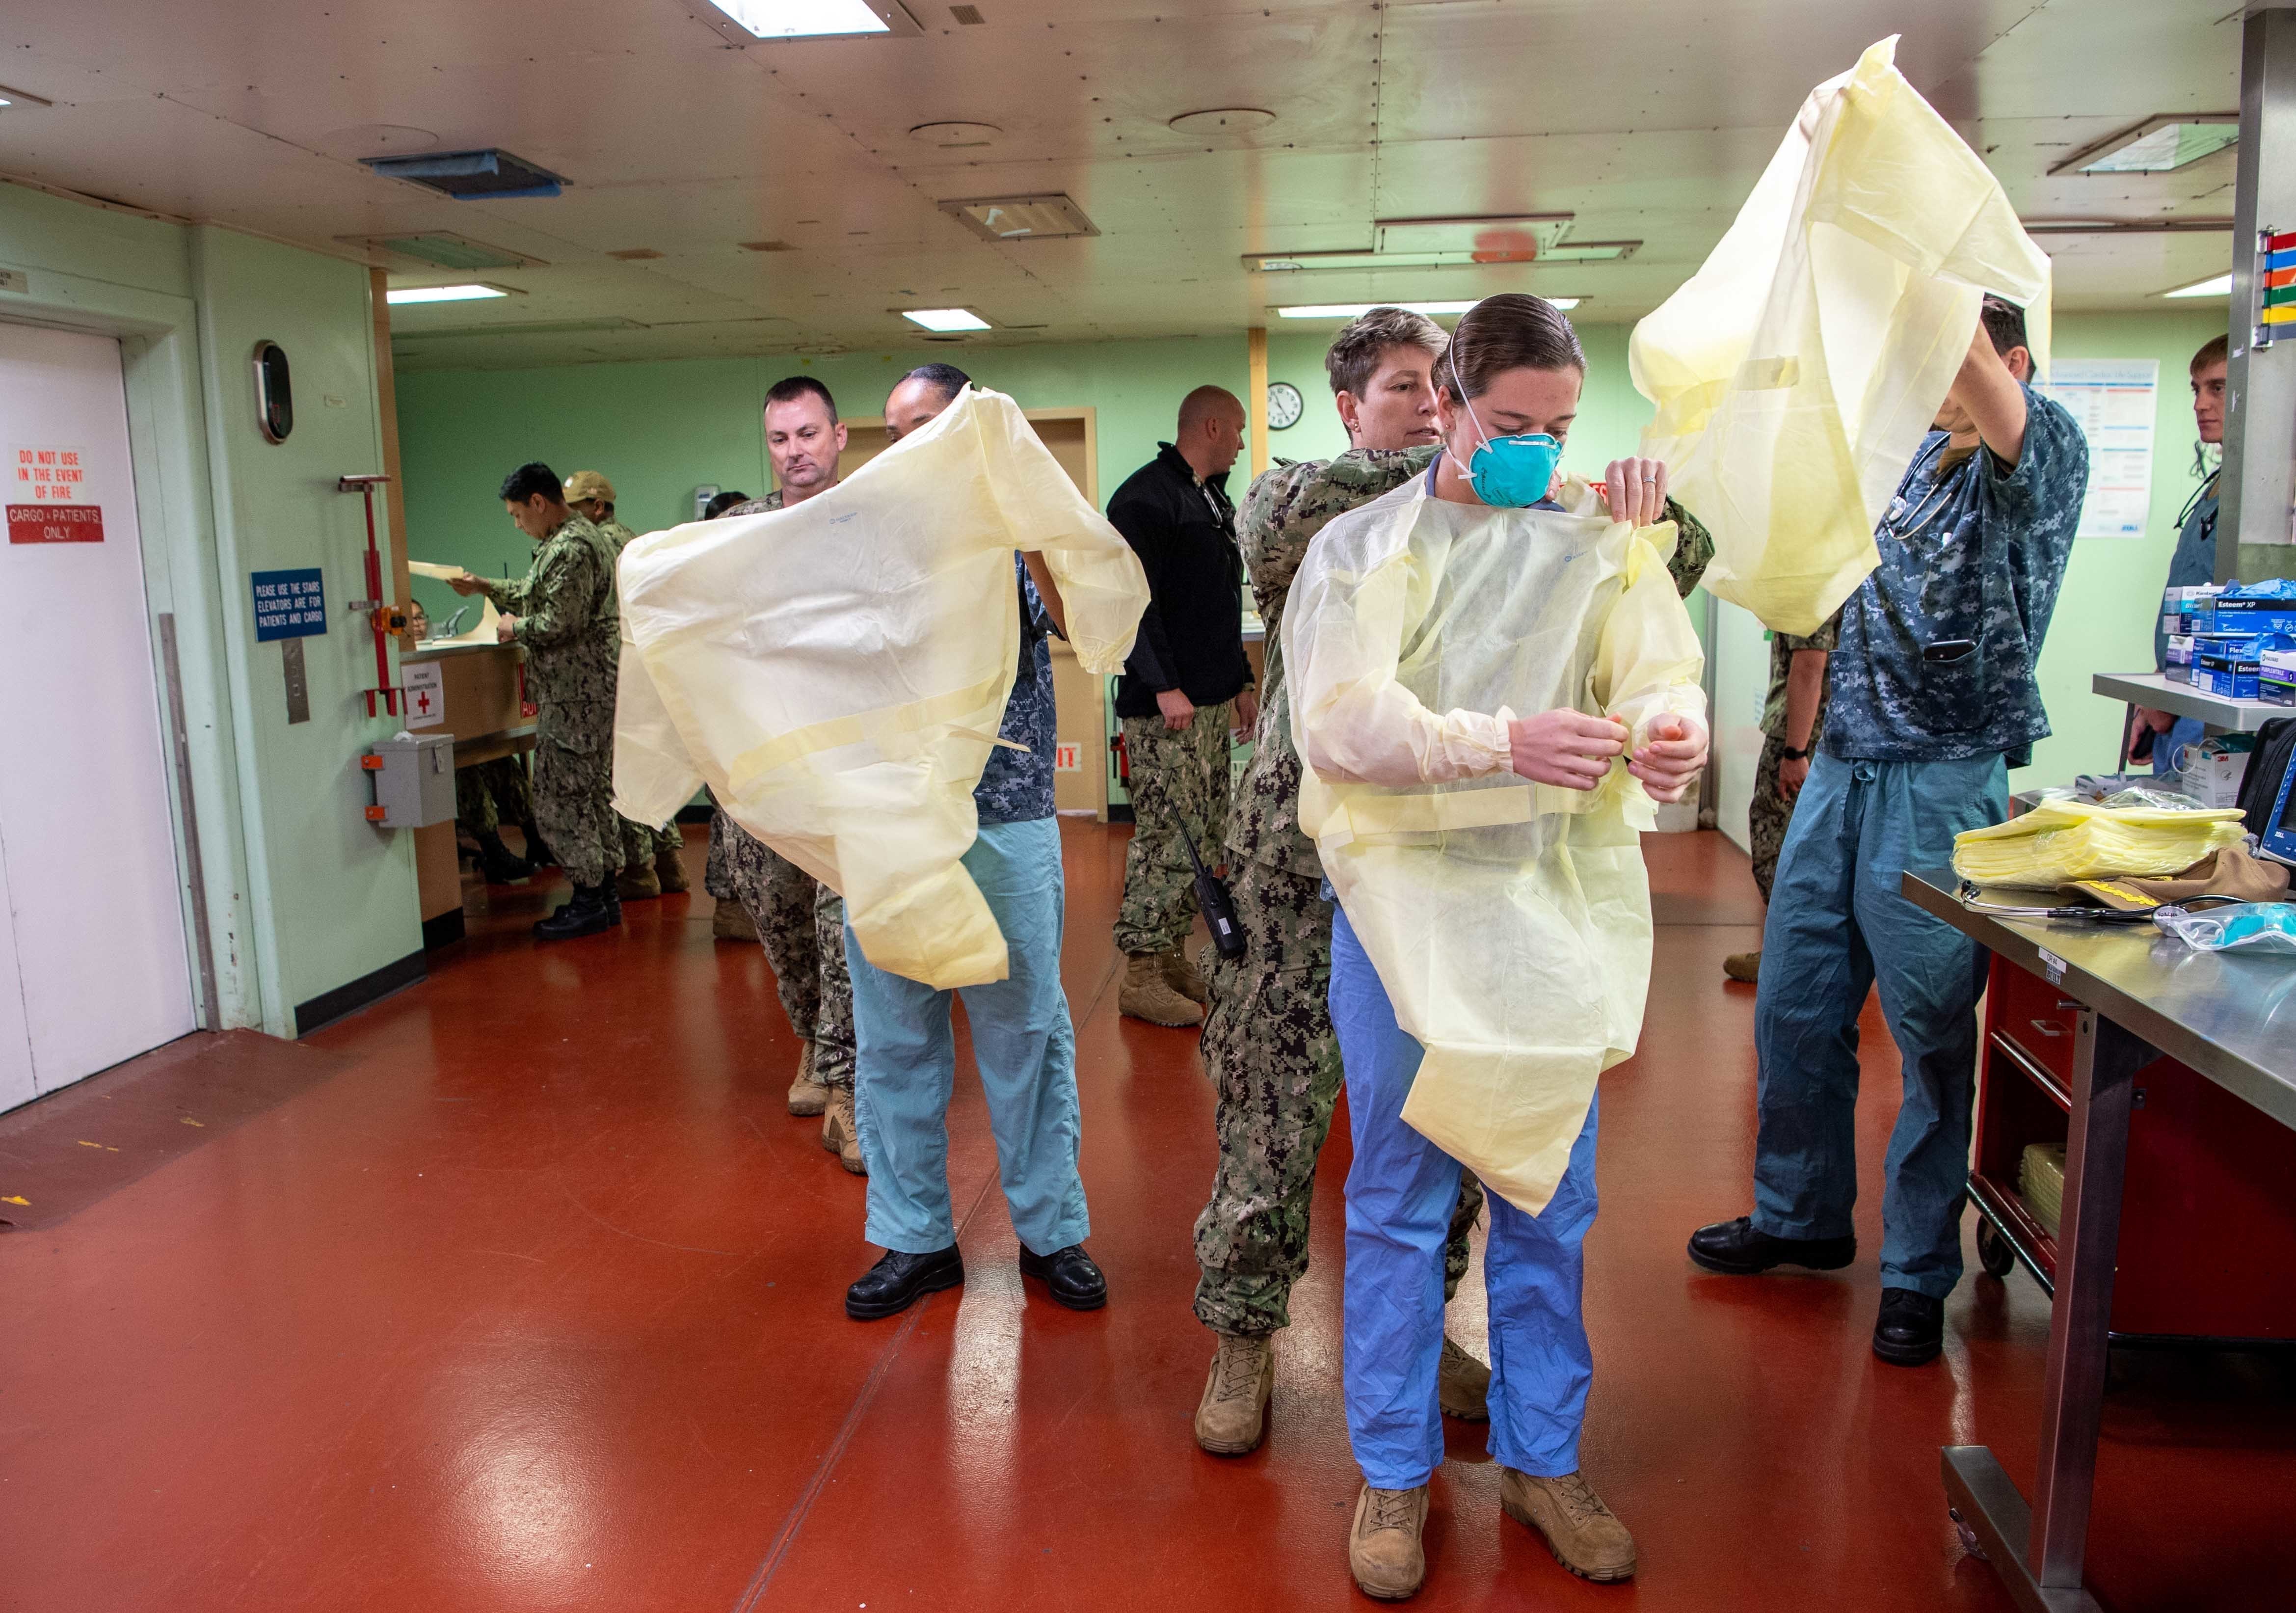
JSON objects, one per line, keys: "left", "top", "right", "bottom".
{"left": 478, "top": 515, "right": 622, "bottom": 885}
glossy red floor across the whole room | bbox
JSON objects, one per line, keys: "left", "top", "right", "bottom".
{"left": 0, "top": 825, "right": 2296, "bottom": 1613}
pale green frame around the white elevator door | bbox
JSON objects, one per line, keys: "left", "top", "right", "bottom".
{"left": 0, "top": 269, "right": 260, "bottom": 1029}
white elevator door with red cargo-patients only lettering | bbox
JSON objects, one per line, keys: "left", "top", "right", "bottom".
{"left": 0, "top": 324, "right": 195, "bottom": 1110}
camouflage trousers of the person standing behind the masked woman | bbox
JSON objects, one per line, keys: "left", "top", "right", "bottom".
{"left": 1196, "top": 861, "right": 1483, "bottom": 1337}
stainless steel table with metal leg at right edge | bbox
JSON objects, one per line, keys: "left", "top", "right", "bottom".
{"left": 1903, "top": 868, "right": 2296, "bottom": 1613}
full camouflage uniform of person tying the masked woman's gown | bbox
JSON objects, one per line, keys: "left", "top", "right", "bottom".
{"left": 1196, "top": 448, "right": 1713, "bottom": 1337}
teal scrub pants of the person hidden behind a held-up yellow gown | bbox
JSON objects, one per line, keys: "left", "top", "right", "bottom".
{"left": 845, "top": 818, "right": 1091, "bottom": 1255}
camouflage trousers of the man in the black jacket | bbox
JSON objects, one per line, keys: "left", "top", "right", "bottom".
{"left": 1116, "top": 703, "right": 1235, "bottom": 951}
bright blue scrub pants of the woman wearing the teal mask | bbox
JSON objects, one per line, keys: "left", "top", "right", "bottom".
{"left": 1332, "top": 910, "right": 1596, "bottom": 1489}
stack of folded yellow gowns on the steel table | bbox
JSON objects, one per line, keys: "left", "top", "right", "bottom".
{"left": 1954, "top": 800, "right": 2243, "bottom": 891}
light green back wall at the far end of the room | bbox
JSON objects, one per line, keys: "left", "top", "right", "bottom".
{"left": 400, "top": 306, "right": 2222, "bottom": 804}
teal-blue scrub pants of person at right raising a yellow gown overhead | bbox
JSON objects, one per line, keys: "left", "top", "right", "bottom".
{"left": 1754, "top": 753, "right": 2009, "bottom": 1298}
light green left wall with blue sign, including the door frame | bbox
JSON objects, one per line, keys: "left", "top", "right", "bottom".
{"left": 0, "top": 184, "right": 420, "bottom": 1034}
